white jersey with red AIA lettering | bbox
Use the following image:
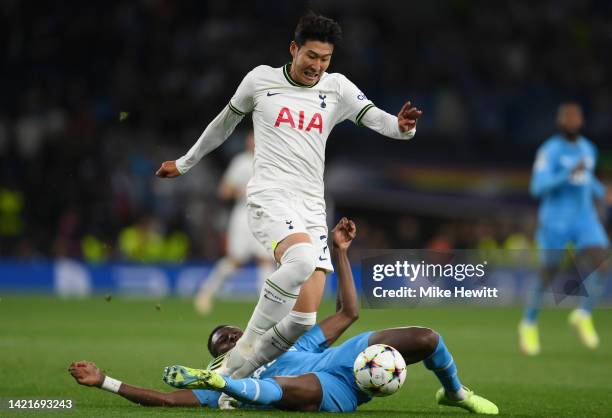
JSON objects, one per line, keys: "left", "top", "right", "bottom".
{"left": 229, "top": 64, "right": 374, "bottom": 199}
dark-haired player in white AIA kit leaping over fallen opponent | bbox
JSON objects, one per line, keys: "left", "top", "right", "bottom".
{"left": 156, "top": 13, "right": 421, "bottom": 378}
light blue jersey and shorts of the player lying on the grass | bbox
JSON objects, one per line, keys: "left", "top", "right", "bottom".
{"left": 193, "top": 325, "right": 371, "bottom": 412}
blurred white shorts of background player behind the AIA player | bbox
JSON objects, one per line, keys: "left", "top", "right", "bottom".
{"left": 227, "top": 201, "right": 270, "bottom": 263}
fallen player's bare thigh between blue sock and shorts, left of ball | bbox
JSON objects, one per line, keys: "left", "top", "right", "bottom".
{"left": 274, "top": 374, "right": 323, "bottom": 412}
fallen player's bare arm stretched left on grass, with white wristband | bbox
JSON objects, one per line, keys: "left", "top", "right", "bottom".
{"left": 68, "top": 361, "right": 200, "bottom": 406}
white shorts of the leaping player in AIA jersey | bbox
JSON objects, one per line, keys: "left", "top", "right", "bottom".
{"left": 247, "top": 189, "right": 334, "bottom": 273}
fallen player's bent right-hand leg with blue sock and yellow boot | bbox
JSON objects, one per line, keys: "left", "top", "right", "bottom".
{"left": 368, "top": 327, "right": 499, "bottom": 415}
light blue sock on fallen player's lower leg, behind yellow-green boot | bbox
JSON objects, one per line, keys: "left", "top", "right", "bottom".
{"left": 222, "top": 376, "right": 283, "bottom": 405}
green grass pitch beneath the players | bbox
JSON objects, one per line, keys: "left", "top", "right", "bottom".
{"left": 0, "top": 295, "right": 612, "bottom": 417}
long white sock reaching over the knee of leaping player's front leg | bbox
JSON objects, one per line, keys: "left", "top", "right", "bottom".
{"left": 236, "top": 242, "right": 315, "bottom": 353}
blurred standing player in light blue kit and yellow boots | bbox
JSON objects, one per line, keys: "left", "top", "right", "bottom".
{"left": 519, "top": 102, "right": 609, "bottom": 355}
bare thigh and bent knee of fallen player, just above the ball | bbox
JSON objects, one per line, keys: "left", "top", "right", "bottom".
{"left": 368, "top": 327, "right": 439, "bottom": 364}
